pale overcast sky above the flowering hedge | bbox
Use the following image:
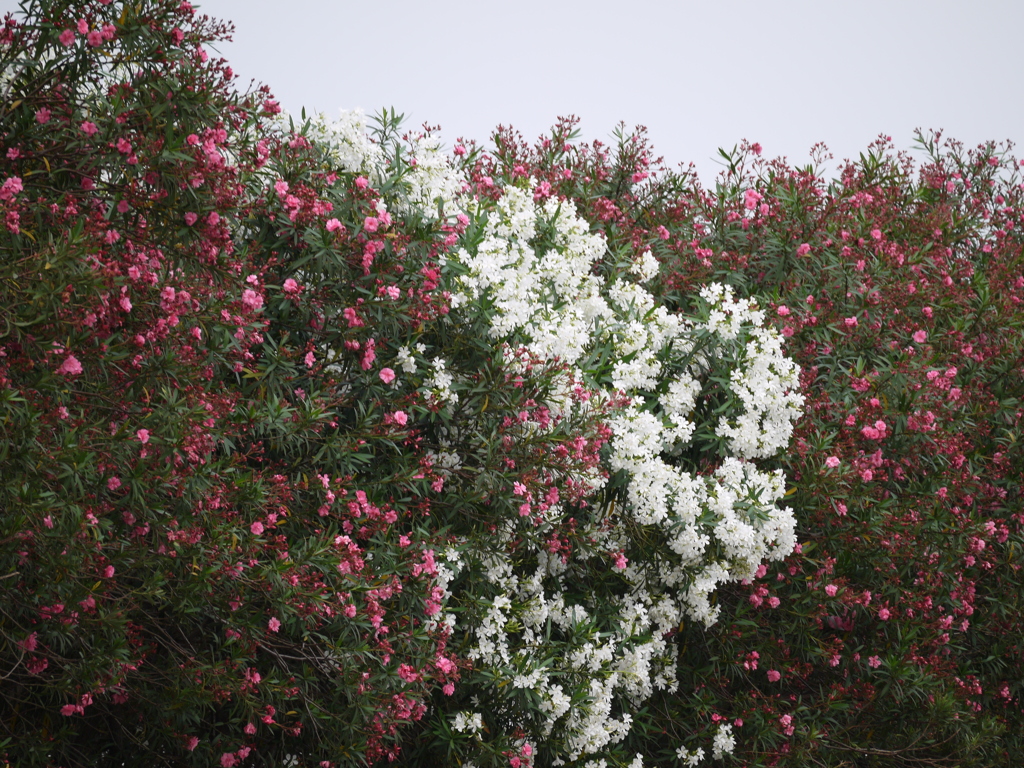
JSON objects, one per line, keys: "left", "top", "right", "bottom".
{"left": 8, "top": 0, "right": 1024, "bottom": 182}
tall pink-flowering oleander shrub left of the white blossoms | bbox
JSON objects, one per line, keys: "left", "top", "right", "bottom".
{"left": 0, "top": 2, "right": 459, "bottom": 766}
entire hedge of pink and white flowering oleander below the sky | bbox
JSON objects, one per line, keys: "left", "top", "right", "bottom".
{"left": 0, "top": 0, "right": 1024, "bottom": 768}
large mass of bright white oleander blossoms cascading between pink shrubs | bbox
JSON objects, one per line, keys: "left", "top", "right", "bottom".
{"left": 442, "top": 179, "right": 802, "bottom": 764}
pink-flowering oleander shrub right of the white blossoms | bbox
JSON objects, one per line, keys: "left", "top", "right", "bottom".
{"left": 498, "top": 124, "right": 1024, "bottom": 765}
